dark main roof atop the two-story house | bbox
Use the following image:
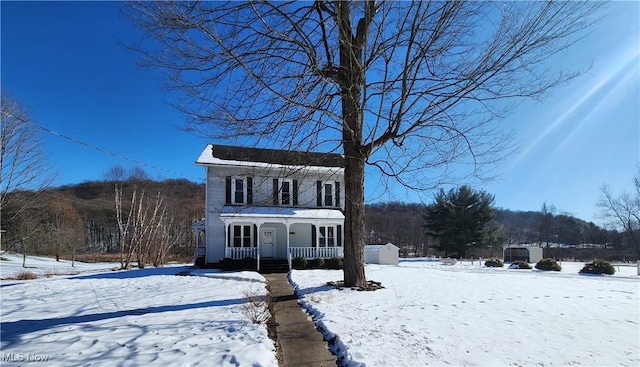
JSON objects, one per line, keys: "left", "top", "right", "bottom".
{"left": 211, "top": 145, "right": 344, "bottom": 167}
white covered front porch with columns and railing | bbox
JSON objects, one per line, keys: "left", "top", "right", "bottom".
{"left": 220, "top": 206, "right": 344, "bottom": 270}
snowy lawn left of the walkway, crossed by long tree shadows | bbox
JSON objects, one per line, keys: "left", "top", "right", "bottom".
{"left": 0, "top": 254, "right": 278, "bottom": 366}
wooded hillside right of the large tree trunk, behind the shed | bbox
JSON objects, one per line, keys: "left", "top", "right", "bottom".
{"left": 366, "top": 202, "right": 635, "bottom": 260}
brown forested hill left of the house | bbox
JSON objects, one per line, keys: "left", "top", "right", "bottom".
{"left": 2, "top": 178, "right": 205, "bottom": 256}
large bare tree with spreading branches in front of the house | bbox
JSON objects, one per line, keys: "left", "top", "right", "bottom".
{"left": 125, "top": 1, "right": 599, "bottom": 286}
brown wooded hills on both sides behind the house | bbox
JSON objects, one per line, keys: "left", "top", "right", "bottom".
{"left": 2, "top": 179, "right": 634, "bottom": 260}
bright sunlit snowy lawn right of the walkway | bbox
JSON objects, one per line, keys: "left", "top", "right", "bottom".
{"left": 290, "top": 260, "right": 640, "bottom": 366}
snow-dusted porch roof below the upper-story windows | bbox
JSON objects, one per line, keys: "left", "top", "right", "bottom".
{"left": 220, "top": 206, "right": 344, "bottom": 222}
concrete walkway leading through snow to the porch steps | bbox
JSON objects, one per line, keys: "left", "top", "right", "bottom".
{"left": 264, "top": 274, "right": 337, "bottom": 367}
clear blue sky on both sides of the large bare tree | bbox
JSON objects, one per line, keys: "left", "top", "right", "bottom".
{"left": 0, "top": 1, "right": 640, "bottom": 223}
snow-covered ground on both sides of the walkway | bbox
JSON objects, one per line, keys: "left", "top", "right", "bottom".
{"left": 0, "top": 254, "right": 640, "bottom": 367}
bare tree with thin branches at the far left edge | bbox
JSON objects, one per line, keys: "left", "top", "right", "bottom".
{"left": 0, "top": 92, "right": 55, "bottom": 250}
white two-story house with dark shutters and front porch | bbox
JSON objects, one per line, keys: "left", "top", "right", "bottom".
{"left": 196, "top": 144, "right": 344, "bottom": 266}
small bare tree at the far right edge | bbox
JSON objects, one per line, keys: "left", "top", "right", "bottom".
{"left": 598, "top": 172, "right": 640, "bottom": 256}
